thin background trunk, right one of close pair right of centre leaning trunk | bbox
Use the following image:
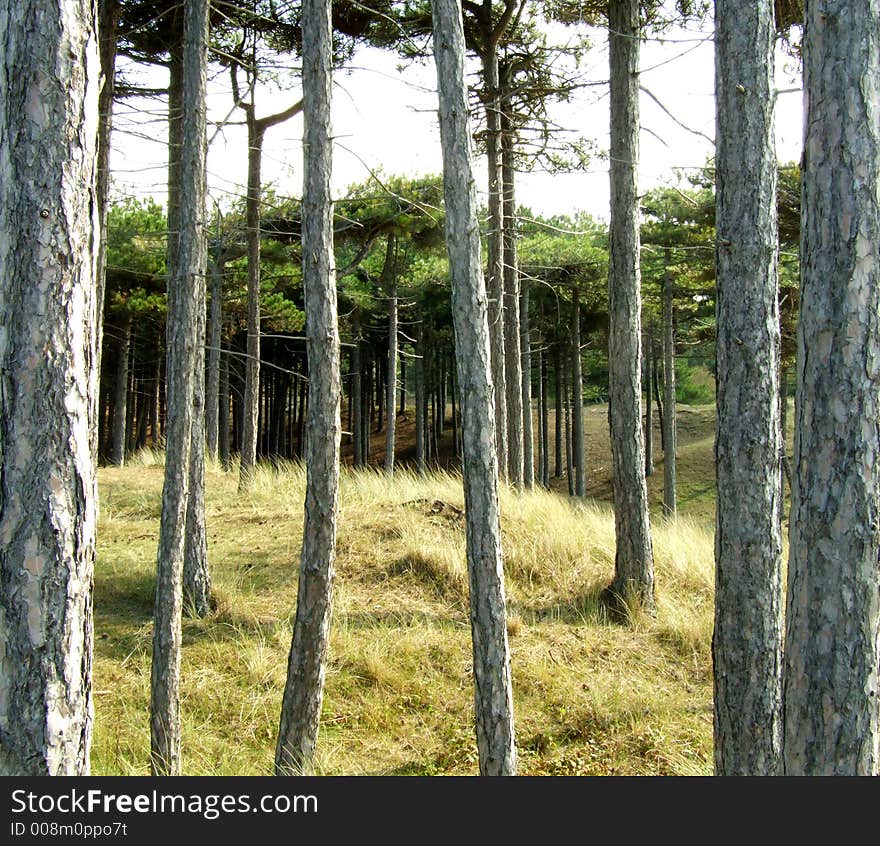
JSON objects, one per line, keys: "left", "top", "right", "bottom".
{"left": 501, "top": 88, "right": 523, "bottom": 490}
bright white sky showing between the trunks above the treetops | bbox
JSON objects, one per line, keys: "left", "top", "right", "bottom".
{"left": 111, "top": 12, "right": 802, "bottom": 224}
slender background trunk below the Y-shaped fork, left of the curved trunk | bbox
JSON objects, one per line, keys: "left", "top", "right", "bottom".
{"left": 238, "top": 120, "right": 264, "bottom": 490}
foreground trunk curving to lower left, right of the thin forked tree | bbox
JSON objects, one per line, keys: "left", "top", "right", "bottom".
{"left": 275, "top": 0, "right": 342, "bottom": 775}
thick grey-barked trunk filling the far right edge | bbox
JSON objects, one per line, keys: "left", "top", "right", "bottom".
{"left": 783, "top": 0, "right": 880, "bottom": 775}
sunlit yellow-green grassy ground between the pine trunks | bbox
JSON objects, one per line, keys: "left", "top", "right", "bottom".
{"left": 92, "top": 406, "right": 792, "bottom": 775}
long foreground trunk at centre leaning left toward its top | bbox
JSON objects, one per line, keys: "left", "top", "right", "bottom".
{"left": 432, "top": 0, "right": 522, "bottom": 775}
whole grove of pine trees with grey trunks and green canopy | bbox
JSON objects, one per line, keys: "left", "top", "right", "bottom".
{"left": 0, "top": 0, "right": 880, "bottom": 775}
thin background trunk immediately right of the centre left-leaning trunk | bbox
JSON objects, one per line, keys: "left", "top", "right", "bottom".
{"left": 483, "top": 46, "right": 507, "bottom": 475}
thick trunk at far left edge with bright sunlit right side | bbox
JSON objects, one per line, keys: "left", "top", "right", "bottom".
{"left": 0, "top": 0, "right": 100, "bottom": 776}
